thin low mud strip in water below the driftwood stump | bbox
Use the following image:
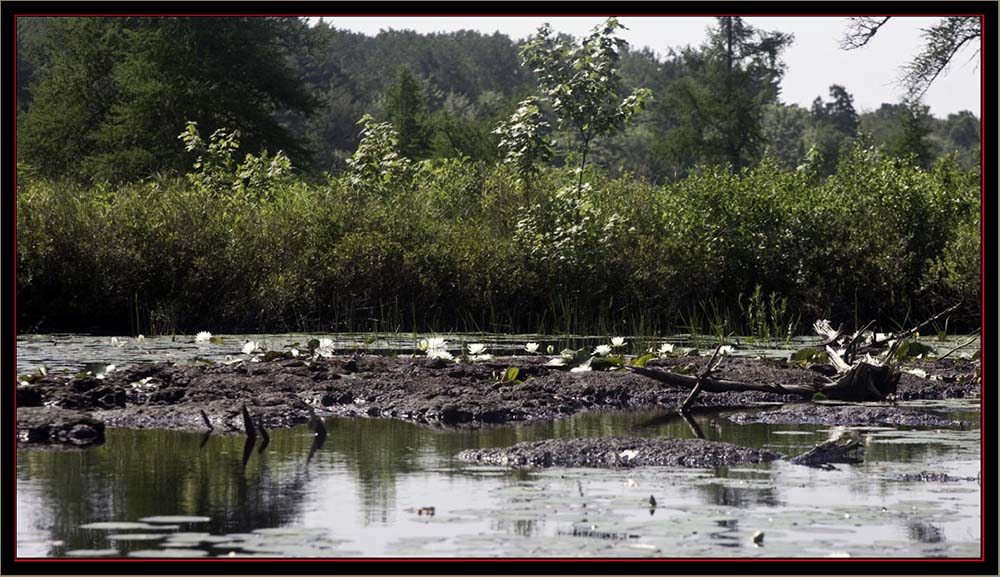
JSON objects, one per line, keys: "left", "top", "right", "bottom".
{"left": 728, "top": 403, "right": 969, "bottom": 427}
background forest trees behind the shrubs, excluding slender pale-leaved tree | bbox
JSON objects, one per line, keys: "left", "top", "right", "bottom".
{"left": 17, "top": 17, "right": 980, "bottom": 182}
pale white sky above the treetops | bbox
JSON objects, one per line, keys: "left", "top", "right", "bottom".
{"left": 314, "top": 16, "right": 982, "bottom": 118}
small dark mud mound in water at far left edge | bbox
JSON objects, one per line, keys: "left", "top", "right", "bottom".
{"left": 17, "top": 407, "right": 104, "bottom": 447}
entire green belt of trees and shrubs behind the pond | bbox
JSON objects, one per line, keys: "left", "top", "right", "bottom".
{"left": 17, "top": 17, "right": 981, "bottom": 336}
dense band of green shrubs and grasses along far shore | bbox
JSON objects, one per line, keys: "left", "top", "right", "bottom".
{"left": 17, "top": 148, "right": 980, "bottom": 336}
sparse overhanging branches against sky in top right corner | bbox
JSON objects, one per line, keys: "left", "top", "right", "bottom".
{"left": 841, "top": 16, "right": 983, "bottom": 100}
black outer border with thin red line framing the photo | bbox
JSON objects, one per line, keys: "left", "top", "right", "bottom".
{"left": 0, "top": 0, "right": 998, "bottom": 575}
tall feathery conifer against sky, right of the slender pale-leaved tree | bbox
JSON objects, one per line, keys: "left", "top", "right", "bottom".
{"left": 657, "top": 16, "right": 792, "bottom": 172}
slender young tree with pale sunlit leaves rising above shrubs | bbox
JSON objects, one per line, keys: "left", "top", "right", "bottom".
{"left": 521, "top": 17, "right": 652, "bottom": 197}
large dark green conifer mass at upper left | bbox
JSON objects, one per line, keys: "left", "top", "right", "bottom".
{"left": 18, "top": 17, "right": 314, "bottom": 181}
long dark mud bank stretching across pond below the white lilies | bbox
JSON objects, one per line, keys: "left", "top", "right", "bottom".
{"left": 17, "top": 356, "right": 978, "bottom": 446}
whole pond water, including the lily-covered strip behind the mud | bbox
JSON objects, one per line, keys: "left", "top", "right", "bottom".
{"left": 16, "top": 335, "right": 982, "bottom": 558}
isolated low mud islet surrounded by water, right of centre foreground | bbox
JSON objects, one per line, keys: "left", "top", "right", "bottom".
{"left": 458, "top": 438, "right": 781, "bottom": 469}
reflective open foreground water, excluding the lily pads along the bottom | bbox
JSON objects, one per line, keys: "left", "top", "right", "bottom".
{"left": 17, "top": 412, "right": 979, "bottom": 555}
